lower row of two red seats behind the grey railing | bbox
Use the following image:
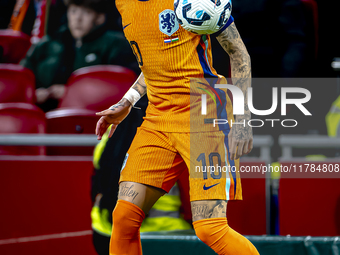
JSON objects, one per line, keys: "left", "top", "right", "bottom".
{"left": 0, "top": 103, "right": 98, "bottom": 155}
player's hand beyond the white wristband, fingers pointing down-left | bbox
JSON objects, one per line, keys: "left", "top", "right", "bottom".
{"left": 96, "top": 98, "right": 132, "bottom": 140}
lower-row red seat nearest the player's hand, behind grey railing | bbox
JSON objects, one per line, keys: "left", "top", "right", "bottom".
{"left": 46, "top": 108, "right": 99, "bottom": 155}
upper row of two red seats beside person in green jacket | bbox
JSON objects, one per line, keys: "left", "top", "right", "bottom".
{"left": 0, "top": 64, "right": 136, "bottom": 108}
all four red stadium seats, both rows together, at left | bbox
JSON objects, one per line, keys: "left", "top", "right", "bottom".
{"left": 0, "top": 64, "right": 136, "bottom": 155}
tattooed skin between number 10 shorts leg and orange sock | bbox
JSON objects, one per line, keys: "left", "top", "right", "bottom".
{"left": 191, "top": 200, "right": 227, "bottom": 221}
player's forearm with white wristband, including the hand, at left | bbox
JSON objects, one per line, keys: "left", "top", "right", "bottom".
{"left": 96, "top": 73, "right": 146, "bottom": 140}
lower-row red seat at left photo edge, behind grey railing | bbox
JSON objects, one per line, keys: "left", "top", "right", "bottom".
{"left": 0, "top": 103, "right": 46, "bottom": 155}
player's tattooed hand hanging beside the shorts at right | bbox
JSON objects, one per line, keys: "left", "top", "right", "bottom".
{"left": 228, "top": 116, "right": 253, "bottom": 160}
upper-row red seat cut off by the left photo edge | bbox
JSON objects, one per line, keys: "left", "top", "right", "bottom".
{"left": 0, "top": 64, "right": 35, "bottom": 104}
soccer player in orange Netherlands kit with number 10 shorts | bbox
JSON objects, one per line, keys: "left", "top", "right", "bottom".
{"left": 96, "top": 0, "right": 258, "bottom": 255}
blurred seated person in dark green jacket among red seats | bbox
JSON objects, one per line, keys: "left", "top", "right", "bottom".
{"left": 21, "top": 0, "right": 139, "bottom": 112}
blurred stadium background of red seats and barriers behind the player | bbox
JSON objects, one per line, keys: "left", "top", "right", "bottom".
{"left": 0, "top": 0, "right": 340, "bottom": 255}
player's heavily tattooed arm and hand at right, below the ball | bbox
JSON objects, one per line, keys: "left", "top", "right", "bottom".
{"left": 217, "top": 22, "right": 253, "bottom": 159}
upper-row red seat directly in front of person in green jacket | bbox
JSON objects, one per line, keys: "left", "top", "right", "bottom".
{"left": 59, "top": 65, "right": 136, "bottom": 111}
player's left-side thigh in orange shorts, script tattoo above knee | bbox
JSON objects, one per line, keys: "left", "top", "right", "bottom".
{"left": 118, "top": 127, "right": 187, "bottom": 213}
